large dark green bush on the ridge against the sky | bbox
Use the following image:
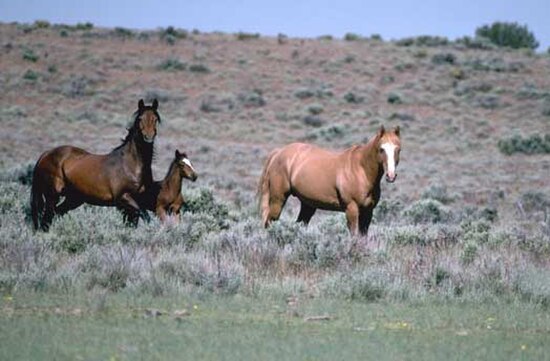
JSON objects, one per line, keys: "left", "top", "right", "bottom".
{"left": 476, "top": 21, "right": 539, "bottom": 49}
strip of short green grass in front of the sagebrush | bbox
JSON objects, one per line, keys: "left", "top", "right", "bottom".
{"left": 0, "top": 294, "right": 550, "bottom": 360}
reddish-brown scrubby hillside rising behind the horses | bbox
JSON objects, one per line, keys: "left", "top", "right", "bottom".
{"left": 0, "top": 24, "right": 550, "bottom": 214}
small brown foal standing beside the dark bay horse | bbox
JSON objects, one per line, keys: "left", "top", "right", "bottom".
{"left": 136, "top": 149, "right": 198, "bottom": 222}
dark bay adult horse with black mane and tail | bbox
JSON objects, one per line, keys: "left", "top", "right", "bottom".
{"left": 31, "top": 99, "right": 161, "bottom": 231}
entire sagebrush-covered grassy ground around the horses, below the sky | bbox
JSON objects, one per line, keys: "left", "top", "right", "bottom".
{"left": 0, "top": 23, "right": 550, "bottom": 360}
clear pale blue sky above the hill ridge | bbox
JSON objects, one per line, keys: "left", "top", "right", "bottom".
{"left": 0, "top": 0, "right": 550, "bottom": 51}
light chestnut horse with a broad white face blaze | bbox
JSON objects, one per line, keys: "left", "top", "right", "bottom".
{"left": 258, "top": 126, "right": 401, "bottom": 235}
